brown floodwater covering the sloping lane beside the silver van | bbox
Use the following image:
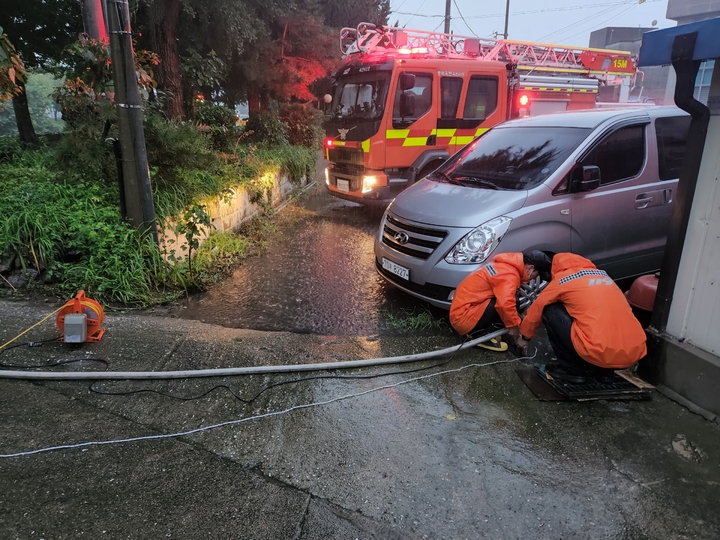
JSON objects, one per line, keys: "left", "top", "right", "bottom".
{"left": 172, "top": 182, "right": 451, "bottom": 336}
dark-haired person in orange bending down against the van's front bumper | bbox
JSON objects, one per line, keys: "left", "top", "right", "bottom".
{"left": 450, "top": 250, "right": 550, "bottom": 351}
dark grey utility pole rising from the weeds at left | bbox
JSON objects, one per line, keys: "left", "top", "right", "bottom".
{"left": 105, "top": 0, "right": 157, "bottom": 243}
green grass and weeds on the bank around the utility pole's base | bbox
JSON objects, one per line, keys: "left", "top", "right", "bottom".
{"left": 0, "top": 111, "right": 316, "bottom": 306}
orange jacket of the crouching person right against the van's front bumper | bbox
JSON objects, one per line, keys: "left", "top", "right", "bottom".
{"left": 450, "top": 253, "right": 529, "bottom": 336}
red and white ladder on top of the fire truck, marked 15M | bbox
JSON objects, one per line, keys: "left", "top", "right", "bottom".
{"left": 340, "top": 23, "right": 637, "bottom": 82}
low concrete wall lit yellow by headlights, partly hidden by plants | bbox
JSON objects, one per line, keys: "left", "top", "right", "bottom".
{"left": 160, "top": 171, "right": 308, "bottom": 259}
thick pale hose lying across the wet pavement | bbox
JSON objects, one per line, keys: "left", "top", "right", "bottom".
{"left": 0, "top": 328, "right": 507, "bottom": 381}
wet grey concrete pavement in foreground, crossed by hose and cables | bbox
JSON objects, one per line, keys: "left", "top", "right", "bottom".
{"left": 0, "top": 301, "right": 720, "bottom": 540}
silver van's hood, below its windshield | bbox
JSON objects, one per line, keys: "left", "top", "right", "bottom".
{"left": 390, "top": 179, "right": 528, "bottom": 227}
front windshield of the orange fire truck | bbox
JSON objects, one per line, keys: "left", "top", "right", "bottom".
{"left": 332, "top": 72, "right": 390, "bottom": 120}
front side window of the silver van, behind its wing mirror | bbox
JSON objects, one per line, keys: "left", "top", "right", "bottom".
{"left": 582, "top": 124, "right": 645, "bottom": 185}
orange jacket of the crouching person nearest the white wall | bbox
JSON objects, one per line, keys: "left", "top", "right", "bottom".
{"left": 520, "top": 253, "right": 647, "bottom": 369}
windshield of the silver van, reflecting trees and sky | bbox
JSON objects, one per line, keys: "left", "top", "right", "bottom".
{"left": 430, "top": 126, "right": 591, "bottom": 190}
